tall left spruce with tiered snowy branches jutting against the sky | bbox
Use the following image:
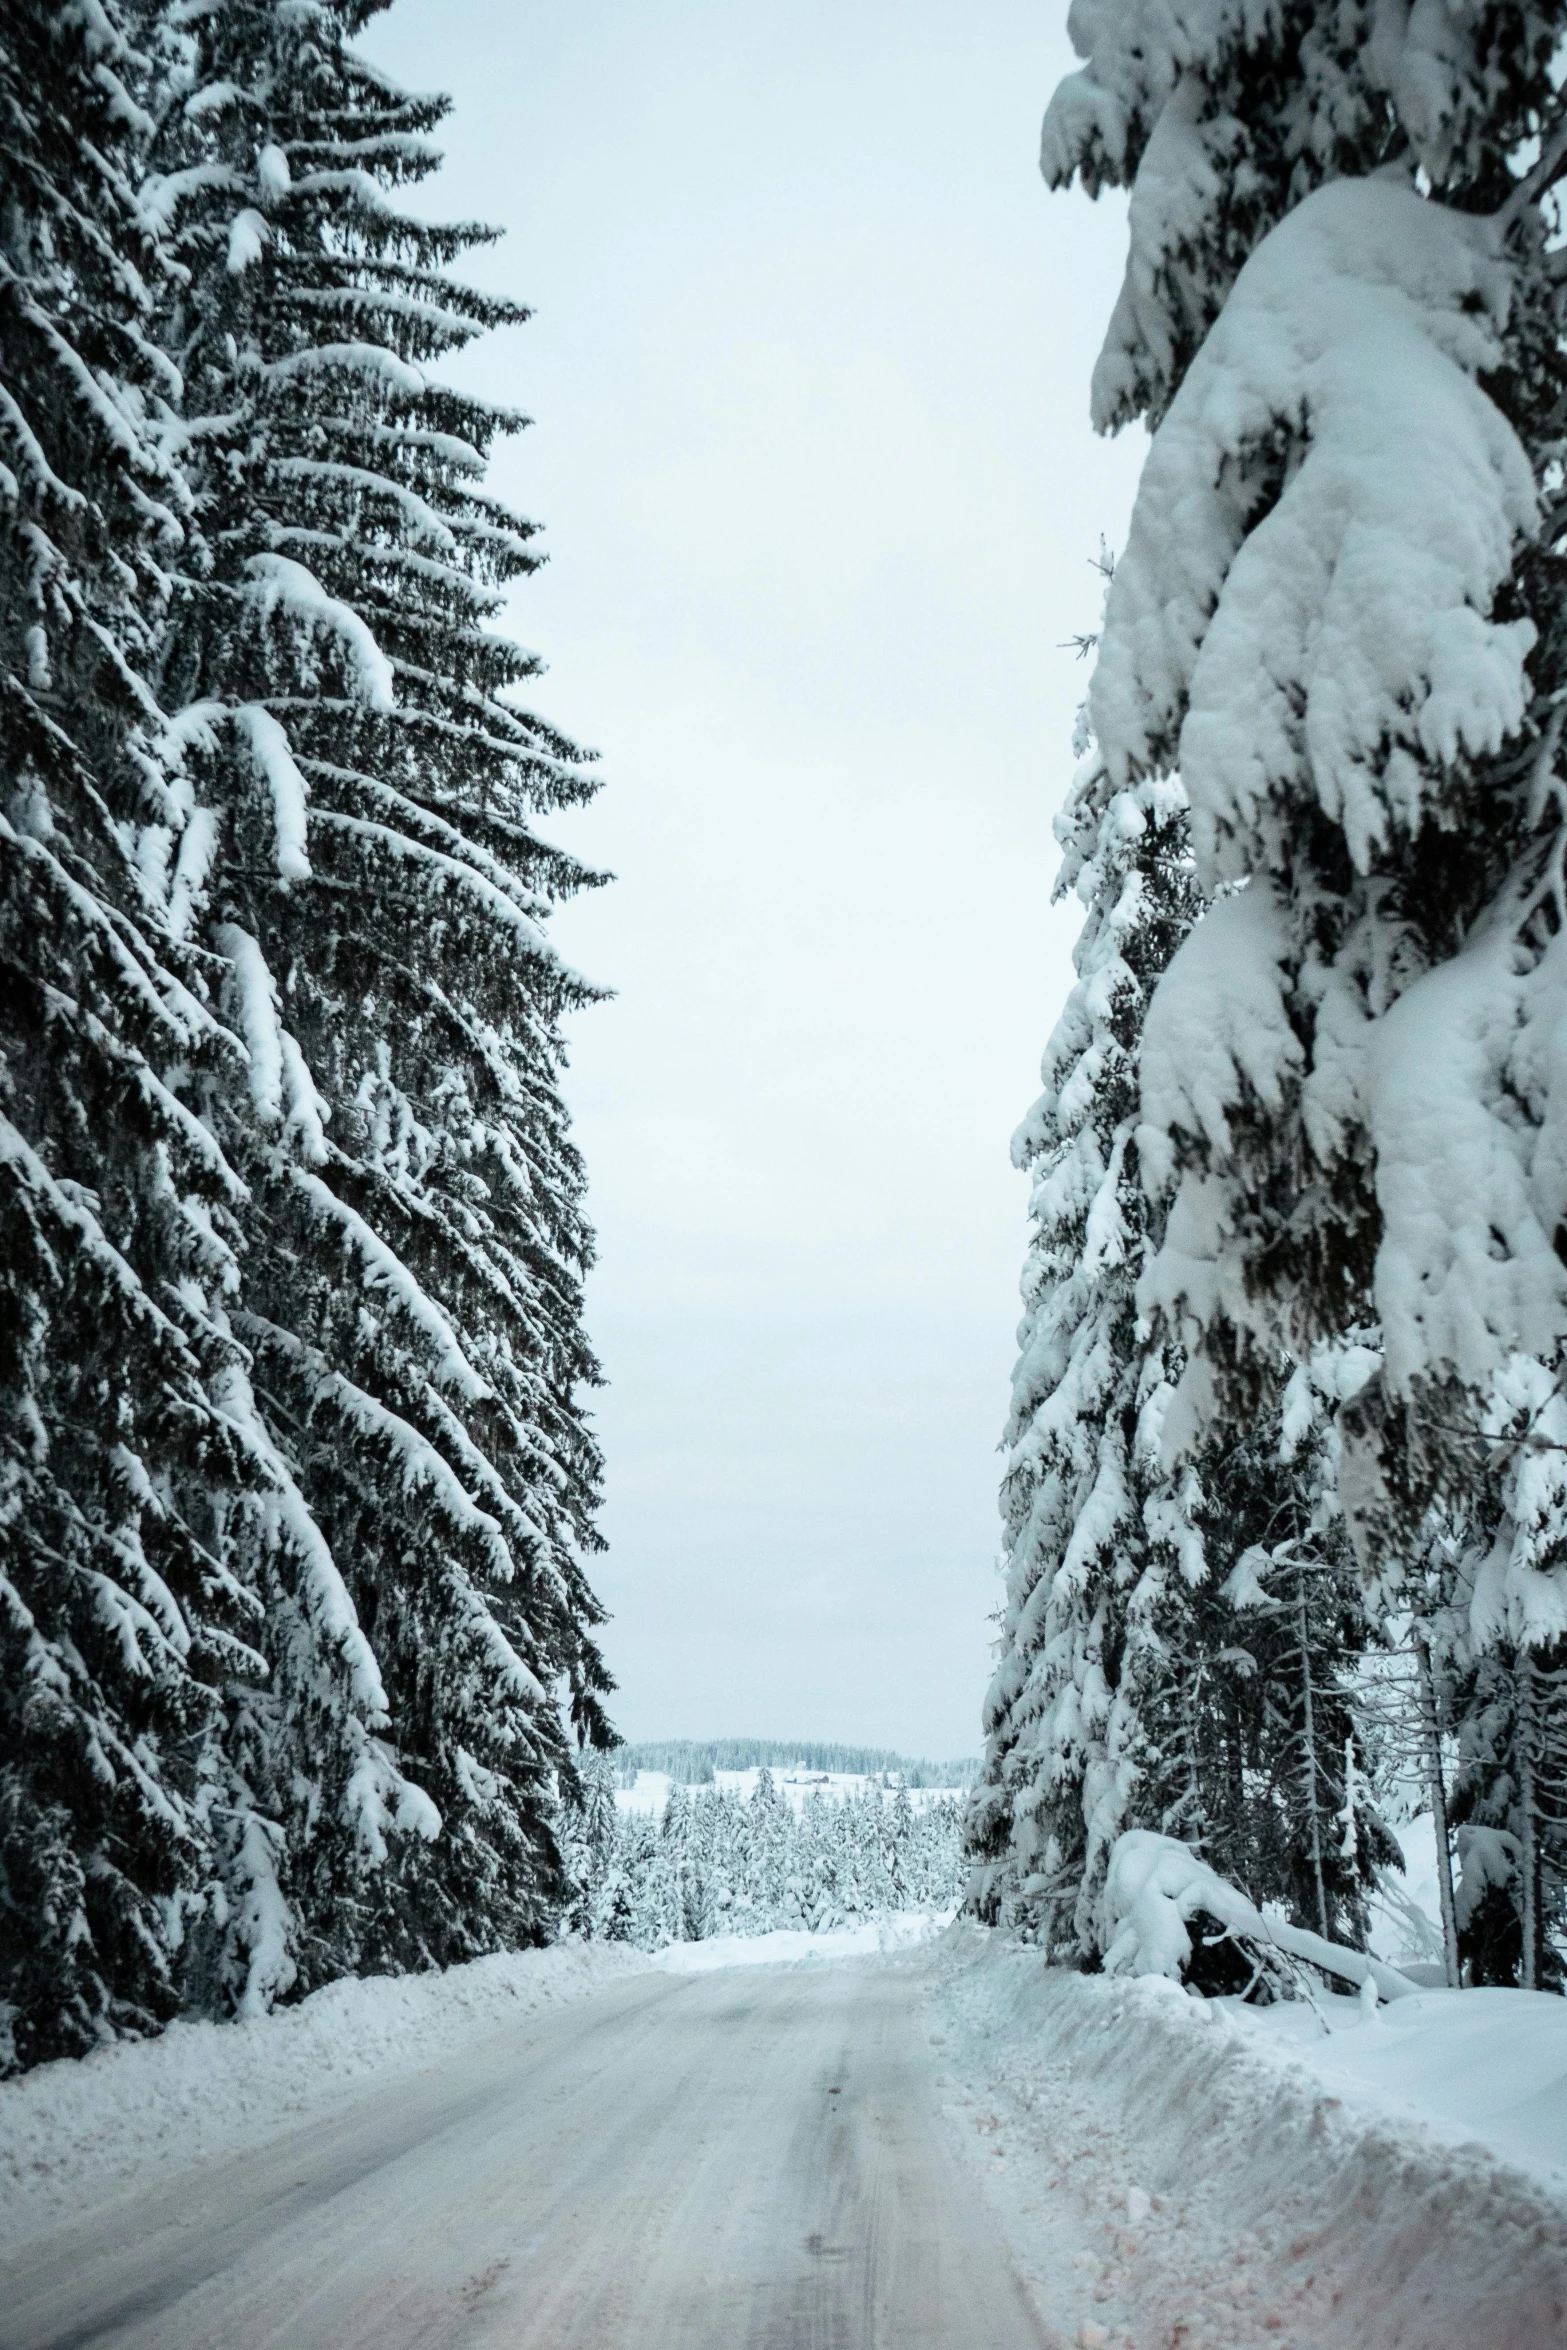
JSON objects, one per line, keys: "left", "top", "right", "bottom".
{"left": 133, "top": 0, "right": 608, "bottom": 1988}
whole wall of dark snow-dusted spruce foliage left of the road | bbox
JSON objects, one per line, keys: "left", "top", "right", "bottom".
{"left": 0, "top": 0, "right": 611, "bottom": 2068}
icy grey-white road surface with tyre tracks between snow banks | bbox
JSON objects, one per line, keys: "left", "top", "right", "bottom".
{"left": 0, "top": 1960, "right": 1055, "bottom": 2350}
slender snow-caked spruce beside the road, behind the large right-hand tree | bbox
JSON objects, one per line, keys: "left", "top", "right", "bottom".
{"left": 968, "top": 709, "right": 1208, "bottom": 1946}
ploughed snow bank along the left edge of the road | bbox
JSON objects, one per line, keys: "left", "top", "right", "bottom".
{"left": 0, "top": 1943, "right": 648, "bottom": 2251}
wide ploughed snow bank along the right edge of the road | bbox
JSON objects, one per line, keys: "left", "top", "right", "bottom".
{"left": 937, "top": 1927, "right": 1567, "bottom": 2350}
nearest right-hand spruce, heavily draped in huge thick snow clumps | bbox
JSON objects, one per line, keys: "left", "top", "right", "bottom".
{"left": 1045, "top": 0, "right": 1567, "bottom": 1983}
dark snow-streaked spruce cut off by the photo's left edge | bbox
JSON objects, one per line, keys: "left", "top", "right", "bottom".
{"left": 0, "top": 0, "right": 263, "bottom": 2073}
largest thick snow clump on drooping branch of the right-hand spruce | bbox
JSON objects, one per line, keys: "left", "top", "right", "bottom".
{"left": 1090, "top": 179, "right": 1536, "bottom": 886}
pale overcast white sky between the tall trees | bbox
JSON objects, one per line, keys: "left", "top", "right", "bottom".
{"left": 366, "top": 0, "right": 1144, "bottom": 1753}
